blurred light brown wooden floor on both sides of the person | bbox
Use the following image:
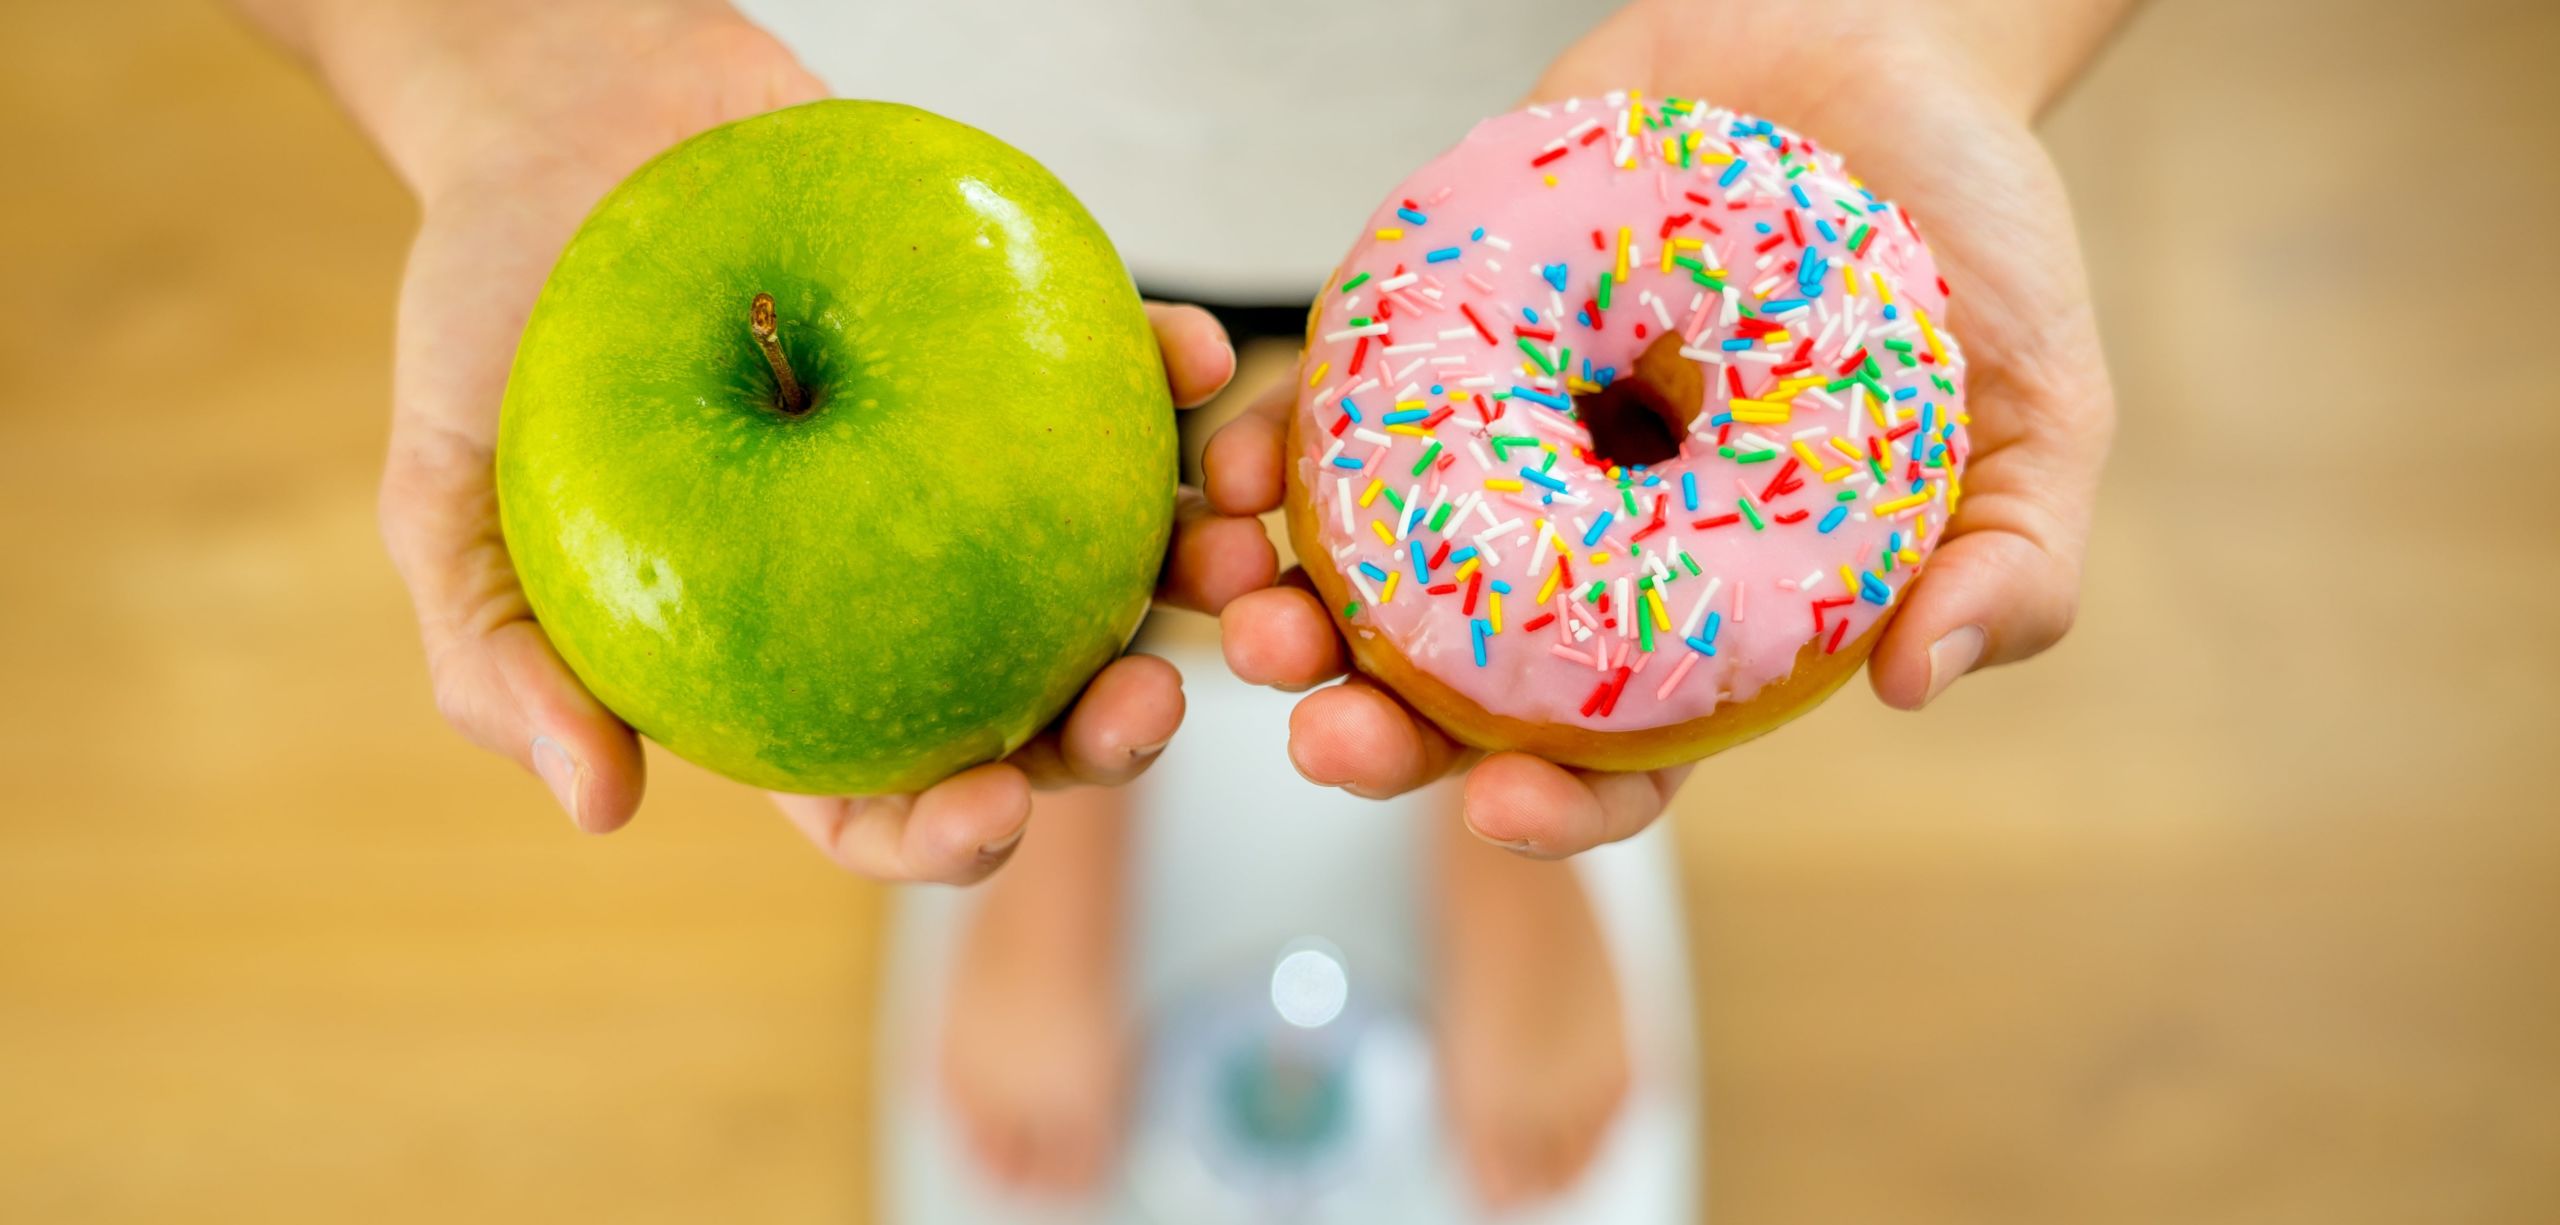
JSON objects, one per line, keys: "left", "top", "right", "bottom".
{"left": 0, "top": 0, "right": 2560, "bottom": 1225}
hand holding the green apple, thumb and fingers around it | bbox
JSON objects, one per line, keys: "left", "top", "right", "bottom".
{"left": 355, "top": 0, "right": 1272, "bottom": 882}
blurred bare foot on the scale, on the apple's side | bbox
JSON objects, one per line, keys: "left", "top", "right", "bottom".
{"left": 942, "top": 788, "right": 1129, "bottom": 1194}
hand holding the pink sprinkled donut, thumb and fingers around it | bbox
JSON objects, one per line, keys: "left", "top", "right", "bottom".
{"left": 1206, "top": 0, "right": 2115, "bottom": 857}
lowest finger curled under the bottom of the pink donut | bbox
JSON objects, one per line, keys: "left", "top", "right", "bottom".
{"left": 1462, "top": 752, "right": 1692, "bottom": 859}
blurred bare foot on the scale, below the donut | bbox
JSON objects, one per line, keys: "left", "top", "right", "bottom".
{"left": 1434, "top": 816, "right": 1628, "bottom": 1207}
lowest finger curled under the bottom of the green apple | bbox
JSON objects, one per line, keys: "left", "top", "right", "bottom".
{"left": 773, "top": 762, "right": 1032, "bottom": 885}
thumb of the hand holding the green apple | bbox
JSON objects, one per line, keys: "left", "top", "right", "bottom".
{"left": 381, "top": 425, "right": 645, "bottom": 834}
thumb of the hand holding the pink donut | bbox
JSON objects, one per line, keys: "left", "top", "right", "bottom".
{"left": 1869, "top": 383, "right": 2107, "bottom": 711}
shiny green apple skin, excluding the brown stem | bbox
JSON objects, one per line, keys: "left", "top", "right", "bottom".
{"left": 497, "top": 100, "right": 1178, "bottom": 795}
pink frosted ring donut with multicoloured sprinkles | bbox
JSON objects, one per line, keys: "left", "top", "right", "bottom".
{"left": 1288, "top": 95, "right": 1969, "bottom": 770}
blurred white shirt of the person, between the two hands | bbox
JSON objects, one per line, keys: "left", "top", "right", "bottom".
{"left": 740, "top": 0, "right": 1613, "bottom": 304}
